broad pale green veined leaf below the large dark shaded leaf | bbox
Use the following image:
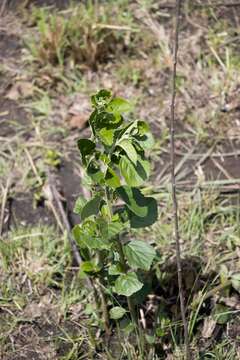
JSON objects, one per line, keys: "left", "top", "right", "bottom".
{"left": 124, "top": 240, "right": 156, "bottom": 271}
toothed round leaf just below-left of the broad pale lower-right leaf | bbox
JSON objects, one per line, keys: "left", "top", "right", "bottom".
{"left": 114, "top": 272, "right": 143, "bottom": 296}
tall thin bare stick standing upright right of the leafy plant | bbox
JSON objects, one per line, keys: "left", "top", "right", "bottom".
{"left": 170, "top": 0, "right": 191, "bottom": 360}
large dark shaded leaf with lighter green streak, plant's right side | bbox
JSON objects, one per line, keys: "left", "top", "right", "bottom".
{"left": 116, "top": 185, "right": 158, "bottom": 228}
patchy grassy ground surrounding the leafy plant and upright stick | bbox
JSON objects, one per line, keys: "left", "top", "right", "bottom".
{"left": 0, "top": 0, "right": 240, "bottom": 360}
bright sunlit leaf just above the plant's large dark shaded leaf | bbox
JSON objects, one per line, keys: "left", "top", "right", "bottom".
{"left": 119, "top": 156, "right": 149, "bottom": 186}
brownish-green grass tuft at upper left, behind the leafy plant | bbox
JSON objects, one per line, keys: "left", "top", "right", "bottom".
{"left": 26, "top": 2, "right": 137, "bottom": 69}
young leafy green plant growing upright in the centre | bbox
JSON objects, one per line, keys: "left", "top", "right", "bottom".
{"left": 73, "top": 90, "right": 157, "bottom": 332}
